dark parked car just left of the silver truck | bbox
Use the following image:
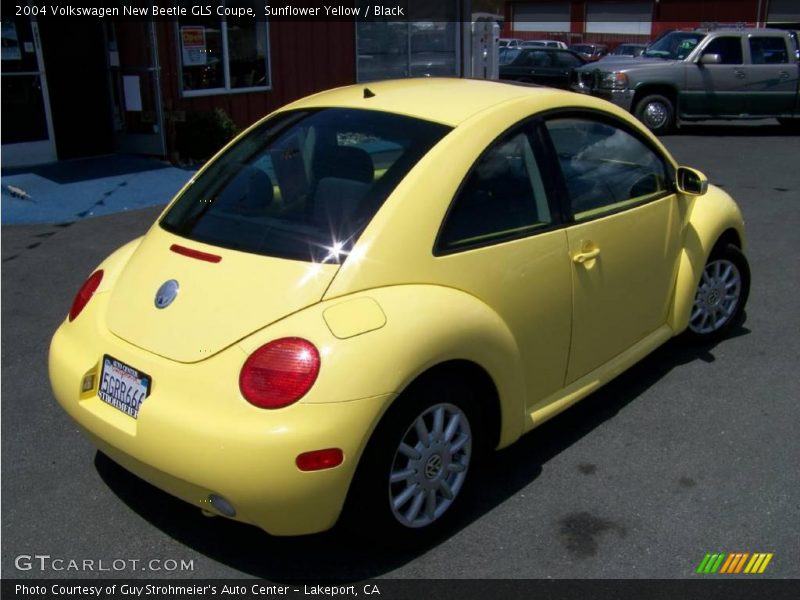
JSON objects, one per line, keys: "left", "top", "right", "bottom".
{"left": 500, "top": 48, "right": 587, "bottom": 89}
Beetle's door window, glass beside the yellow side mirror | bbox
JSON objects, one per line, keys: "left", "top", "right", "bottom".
{"left": 546, "top": 118, "right": 669, "bottom": 221}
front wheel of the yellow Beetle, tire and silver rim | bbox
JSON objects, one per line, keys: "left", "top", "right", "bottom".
{"left": 682, "top": 244, "right": 750, "bottom": 345}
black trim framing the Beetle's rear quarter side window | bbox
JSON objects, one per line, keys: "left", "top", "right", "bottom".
{"left": 432, "top": 114, "right": 566, "bottom": 257}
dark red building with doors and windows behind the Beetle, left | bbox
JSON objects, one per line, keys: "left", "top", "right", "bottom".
{"left": 2, "top": 0, "right": 471, "bottom": 167}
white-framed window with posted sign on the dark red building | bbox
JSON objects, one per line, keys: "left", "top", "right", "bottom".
{"left": 178, "top": 3, "right": 271, "bottom": 96}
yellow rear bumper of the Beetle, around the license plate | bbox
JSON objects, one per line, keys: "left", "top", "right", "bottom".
{"left": 49, "top": 298, "right": 394, "bottom": 535}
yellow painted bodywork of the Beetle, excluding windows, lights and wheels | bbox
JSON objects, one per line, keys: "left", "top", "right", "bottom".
{"left": 49, "top": 79, "right": 744, "bottom": 535}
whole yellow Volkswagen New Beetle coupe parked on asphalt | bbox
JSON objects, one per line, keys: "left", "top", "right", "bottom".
{"left": 49, "top": 79, "right": 750, "bottom": 537}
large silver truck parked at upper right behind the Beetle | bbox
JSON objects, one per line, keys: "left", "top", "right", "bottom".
{"left": 570, "top": 29, "right": 800, "bottom": 134}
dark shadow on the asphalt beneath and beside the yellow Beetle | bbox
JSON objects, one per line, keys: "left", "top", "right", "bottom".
{"left": 95, "top": 326, "right": 749, "bottom": 582}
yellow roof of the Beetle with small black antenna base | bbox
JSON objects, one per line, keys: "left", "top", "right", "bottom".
{"left": 281, "top": 77, "right": 573, "bottom": 127}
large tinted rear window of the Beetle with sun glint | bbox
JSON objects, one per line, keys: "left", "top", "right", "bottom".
{"left": 160, "top": 108, "right": 450, "bottom": 263}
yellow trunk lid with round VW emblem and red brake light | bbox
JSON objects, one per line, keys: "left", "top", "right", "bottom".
{"left": 107, "top": 225, "right": 338, "bottom": 363}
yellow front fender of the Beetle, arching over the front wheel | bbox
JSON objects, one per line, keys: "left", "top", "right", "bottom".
{"left": 669, "top": 186, "right": 747, "bottom": 334}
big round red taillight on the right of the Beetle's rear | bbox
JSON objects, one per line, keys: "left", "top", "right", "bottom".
{"left": 239, "top": 338, "right": 319, "bottom": 408}
